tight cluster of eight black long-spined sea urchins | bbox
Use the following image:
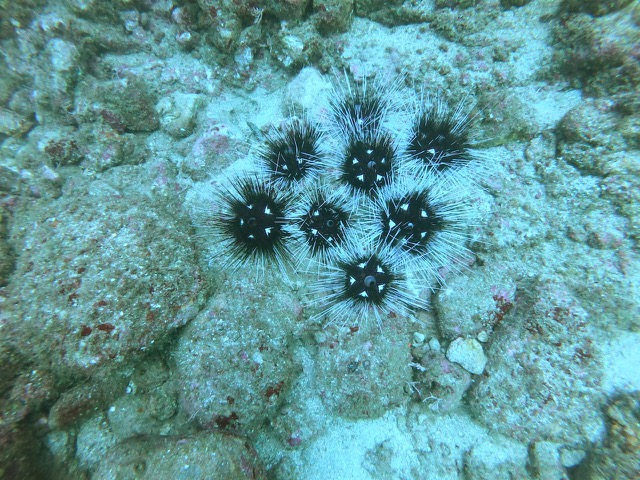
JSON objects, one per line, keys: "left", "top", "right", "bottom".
{"left": 212, "top": 76, "right": 477, "bottom": 330}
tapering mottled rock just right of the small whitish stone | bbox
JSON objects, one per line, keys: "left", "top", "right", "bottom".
{"left": 469, "top": 279, "right": 604, "bottom": 444}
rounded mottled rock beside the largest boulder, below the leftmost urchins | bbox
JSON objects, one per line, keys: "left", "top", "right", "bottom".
{"left": 173, "top": 268, "right": 300, "bottom": 433}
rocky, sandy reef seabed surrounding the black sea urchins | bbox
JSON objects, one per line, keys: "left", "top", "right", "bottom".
{"left": 0, "top": 0, "right": 640, "bottom": 480}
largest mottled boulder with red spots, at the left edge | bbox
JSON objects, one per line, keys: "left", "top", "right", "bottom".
{"left": 3, "top": 169, "right": 206, "bottom": 383}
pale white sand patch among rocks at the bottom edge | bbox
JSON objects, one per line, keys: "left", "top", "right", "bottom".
{"left": 300, "top": 409, "right": 527, "bottom": 480}
